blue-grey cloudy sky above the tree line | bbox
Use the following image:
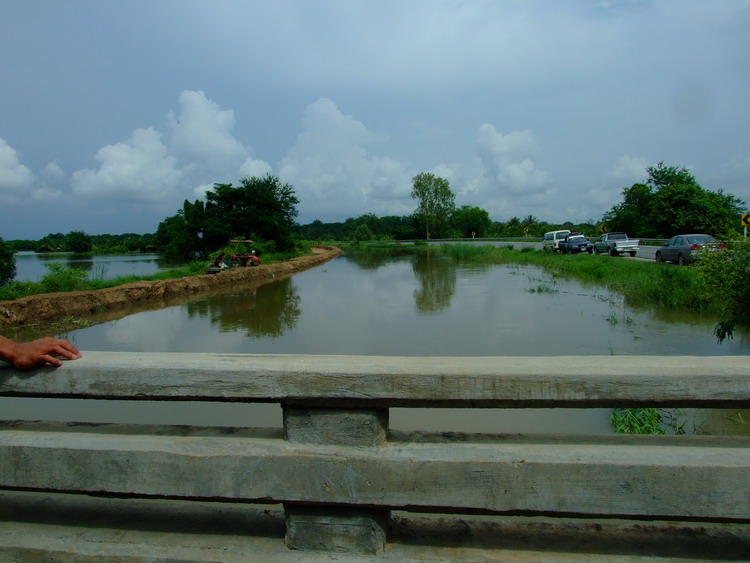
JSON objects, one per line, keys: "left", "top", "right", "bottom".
{"left": 0, "top": 0, "right": 750, "bottom": 240}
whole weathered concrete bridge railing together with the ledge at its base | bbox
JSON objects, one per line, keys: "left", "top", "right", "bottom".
{"left": 0, "top": 351, "right": 750, "bottom": 561}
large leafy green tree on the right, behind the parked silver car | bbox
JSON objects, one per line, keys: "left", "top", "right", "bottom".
{"left": 604, "top": 162, "right": 744, "bottom": 238}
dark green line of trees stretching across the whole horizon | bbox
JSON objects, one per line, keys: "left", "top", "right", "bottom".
{"left": 0, "top": 162, "right": 745, "bottom": 268}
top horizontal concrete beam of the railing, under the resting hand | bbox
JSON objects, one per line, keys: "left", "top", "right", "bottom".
{"left": 0, "top": 350, "right": 750, "bottom": 408}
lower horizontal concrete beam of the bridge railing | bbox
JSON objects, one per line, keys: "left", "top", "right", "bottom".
{"left": 0, "top": 423, "right": 750, "bottom": 521}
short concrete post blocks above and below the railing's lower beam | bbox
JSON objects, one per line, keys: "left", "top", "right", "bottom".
{"left": 284, "top": 405, "right": 390, "bottom": 554}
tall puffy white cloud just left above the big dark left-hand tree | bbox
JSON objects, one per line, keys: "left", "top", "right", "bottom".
{"left": 72, "top": 128, "right": 183, "bottom": 202}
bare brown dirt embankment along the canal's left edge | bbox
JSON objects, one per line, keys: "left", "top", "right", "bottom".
{"left": 0, "top": 246, "right": 341, "bottom": 330}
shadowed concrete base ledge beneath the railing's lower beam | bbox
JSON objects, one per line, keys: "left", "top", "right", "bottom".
{"left": 0, "top": 491, "right": 750, "bottom": 563}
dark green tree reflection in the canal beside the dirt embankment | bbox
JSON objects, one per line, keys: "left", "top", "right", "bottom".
{"left": 185, "top": 278, "right": 302, "bottom": 338}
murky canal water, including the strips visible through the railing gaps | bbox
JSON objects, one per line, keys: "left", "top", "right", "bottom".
{"left": 0, "top": 248, "right": 750, "bottom": 434}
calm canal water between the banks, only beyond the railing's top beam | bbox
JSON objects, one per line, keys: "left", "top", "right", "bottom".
{"left": 58, "top": 249, "right": 750, "bottom": 356}
